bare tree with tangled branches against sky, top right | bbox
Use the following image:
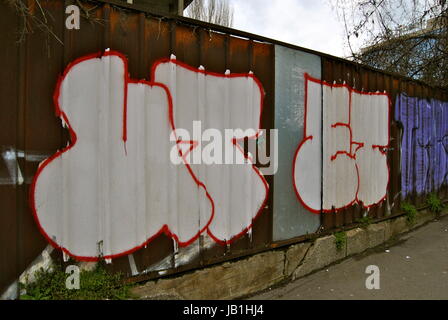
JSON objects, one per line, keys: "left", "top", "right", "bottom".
{"left": 330, "top": 0, "right": 448, "bottom": 88}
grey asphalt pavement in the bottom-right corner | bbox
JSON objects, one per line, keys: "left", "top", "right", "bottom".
{"left": 250, "top": 216, "right": 448, "bottom": 300}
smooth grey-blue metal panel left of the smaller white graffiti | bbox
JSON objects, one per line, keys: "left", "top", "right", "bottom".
{"left": 273, "top": 46, "right": 321, "bottom": 241}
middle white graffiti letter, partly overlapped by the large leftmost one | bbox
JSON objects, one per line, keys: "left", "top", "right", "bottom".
{"left": 154, "top": 58, "right": 268, "bottom": 243}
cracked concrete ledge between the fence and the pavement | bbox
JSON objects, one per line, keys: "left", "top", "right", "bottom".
{"left": 131, "top": 211, "right": 448, "bottom": 300}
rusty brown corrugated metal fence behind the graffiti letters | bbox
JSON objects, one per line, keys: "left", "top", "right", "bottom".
{"left": 0, "top": 0, "right": 448, "bottom": 291}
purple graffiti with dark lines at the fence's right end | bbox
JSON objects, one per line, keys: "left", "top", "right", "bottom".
{"left": 395, "top": 94, "right": 448, "bottom": 197}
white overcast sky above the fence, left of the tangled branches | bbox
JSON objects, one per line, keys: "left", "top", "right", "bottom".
{"left": 229, "top": 0, "right": 348, "bottom": 57}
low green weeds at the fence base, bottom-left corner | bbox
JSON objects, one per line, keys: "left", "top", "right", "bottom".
{"left": 20, "top": 263, "right": 130, "bottom": 300}
